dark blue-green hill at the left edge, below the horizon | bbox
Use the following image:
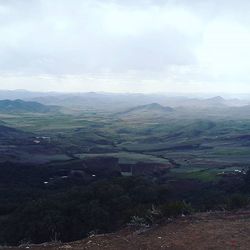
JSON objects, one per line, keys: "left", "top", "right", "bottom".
{"left": 0, "top": 99, "right": 58, "bottom": 113}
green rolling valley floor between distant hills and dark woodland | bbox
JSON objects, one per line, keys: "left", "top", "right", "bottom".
{"left": 0, "top": 108, "right": 250, "bottom": 180}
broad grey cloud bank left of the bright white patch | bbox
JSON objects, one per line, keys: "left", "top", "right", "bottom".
{"left": 0, "top": 1, "right": 200, "bottom": 74}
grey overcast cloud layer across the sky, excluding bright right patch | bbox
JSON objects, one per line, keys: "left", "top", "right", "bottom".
{"left": 0, "top": 0, "right": 250, "bottom": 93}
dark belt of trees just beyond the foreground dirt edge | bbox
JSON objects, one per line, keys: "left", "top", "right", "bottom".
{"left": 0, "top": 161, "right": 250, "bottom": 245}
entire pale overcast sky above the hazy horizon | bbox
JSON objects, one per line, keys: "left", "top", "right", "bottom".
{"left": 0, "top": 0, "right": 250, "bottom": 93}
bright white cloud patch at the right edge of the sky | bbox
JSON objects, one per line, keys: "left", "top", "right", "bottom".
{"left": 198, "top": 20, "right": 250, "bottom": 80}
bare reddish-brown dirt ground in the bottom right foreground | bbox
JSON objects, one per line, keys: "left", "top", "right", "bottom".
{"left": 3, "top": 211, "right": 250, "bottom": 250}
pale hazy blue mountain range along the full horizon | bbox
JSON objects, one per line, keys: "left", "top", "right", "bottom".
{"left": 0, "top": 90, "right": 250, "bottom": 113}
